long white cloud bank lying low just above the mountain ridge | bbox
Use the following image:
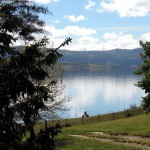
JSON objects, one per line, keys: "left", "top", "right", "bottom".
{"left": 35, "top": 25, "right": 150, "bottom": 51}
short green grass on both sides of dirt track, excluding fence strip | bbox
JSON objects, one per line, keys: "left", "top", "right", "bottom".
{"left": 54, "top": 114, "right": 150, "bottom": 150}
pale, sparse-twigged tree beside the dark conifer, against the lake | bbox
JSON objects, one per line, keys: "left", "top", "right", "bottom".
{"left": 40, "top": 63, "right": 70, "bottom": 120}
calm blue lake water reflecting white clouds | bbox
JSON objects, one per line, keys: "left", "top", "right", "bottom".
{"left": 63, "top": 68, "right": 144, "bottom": 118}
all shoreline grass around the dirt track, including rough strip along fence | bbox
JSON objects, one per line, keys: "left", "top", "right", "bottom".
{"left": 35, "top": 110, "right": 150, "bottom": 150}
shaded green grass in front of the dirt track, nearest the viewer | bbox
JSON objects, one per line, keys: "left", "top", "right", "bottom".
{"left": 56, "top": 135, "right": 141, "bottom": 150}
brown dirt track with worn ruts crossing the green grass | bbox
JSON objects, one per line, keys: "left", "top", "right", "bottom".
{"left": 70, "top": 132, "right": 150, "bottom": 150}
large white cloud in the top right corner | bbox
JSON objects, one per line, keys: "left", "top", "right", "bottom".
{"left": 97, "top": 0, "right": 150, "bottom": 17}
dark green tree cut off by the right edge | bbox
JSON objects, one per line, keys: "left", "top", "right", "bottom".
{"left": 135, "top": 41, "right": 150, "bottom": 112}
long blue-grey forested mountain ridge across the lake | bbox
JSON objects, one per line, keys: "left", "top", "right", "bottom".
{"left": 59, "top": 48, "right": 142, "bottom": 67}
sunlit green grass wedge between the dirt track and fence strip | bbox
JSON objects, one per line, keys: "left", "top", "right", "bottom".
{"left": 58, "top": 114, "right": 150, "bottom": 137}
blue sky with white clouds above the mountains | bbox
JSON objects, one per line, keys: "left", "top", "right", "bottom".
{"left": 34, "top": 0, "right": 150, "bottom": 51}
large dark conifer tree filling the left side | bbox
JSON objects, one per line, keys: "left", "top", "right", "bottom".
{"left": 0, "top": 0, "right": 71, "bottom": 150}
